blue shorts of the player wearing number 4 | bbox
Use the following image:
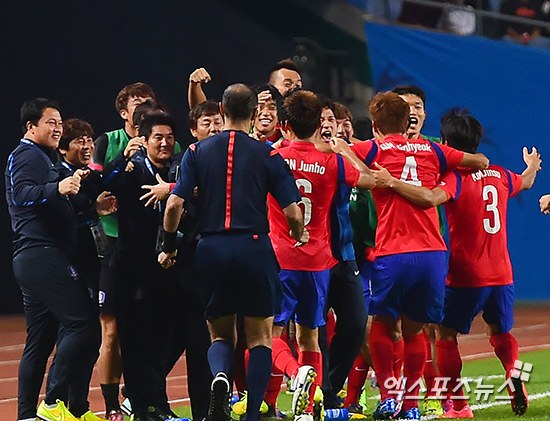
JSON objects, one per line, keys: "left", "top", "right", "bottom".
{"left": 369, "top": 251, "right": 447, "bottom": 324}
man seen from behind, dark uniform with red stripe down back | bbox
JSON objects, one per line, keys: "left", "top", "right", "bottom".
{"left": 159, "top": 84, "right": 308, "bottom": 421}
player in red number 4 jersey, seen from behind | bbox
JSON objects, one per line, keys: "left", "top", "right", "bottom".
{"left": 352, "top": 92, "right": 488, "bottom": 419}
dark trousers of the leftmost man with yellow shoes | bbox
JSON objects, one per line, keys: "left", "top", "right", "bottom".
{"left": 13, "top": 247, "right": 101, "bottom": 419}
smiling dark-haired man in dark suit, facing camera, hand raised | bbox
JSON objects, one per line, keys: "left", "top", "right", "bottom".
{"left": 105, "top": 112, "right": 188, "bottom": 421}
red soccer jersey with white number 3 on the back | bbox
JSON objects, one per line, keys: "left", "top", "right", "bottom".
{"left": 439, "top": 165, "right": 523, "bottom": 288}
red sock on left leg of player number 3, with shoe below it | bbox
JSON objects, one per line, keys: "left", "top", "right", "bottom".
{"left": 435, "top": 339, "right": 468, "bottom": 411}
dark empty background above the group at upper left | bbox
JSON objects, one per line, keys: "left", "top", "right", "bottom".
{"left": 0, "top": 0, "right": 369, "bottom": 313}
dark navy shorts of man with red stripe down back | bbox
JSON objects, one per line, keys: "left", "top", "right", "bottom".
{"left": 196, "top": 233, "right": 282, "bottom": 319}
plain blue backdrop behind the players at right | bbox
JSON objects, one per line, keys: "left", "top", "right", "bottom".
{"left": 365, "top": 23, "right": 550, "bottom": 300}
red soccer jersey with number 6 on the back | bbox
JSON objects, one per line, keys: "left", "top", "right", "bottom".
{"left": 268, "top": 141, "right": 360, "bottom": 271}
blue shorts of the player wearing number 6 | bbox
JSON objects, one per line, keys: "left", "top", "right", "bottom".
{"left": 275, "top": 269, "right": 330, "bottom": 329}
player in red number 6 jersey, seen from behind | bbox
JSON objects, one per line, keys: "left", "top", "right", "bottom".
{"left": 268, "top": 91, "right": 374, "bottom": 419}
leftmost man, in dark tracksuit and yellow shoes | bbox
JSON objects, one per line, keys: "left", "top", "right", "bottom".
{"left": 5, "top": 98, "right": 101, "bottom": 420}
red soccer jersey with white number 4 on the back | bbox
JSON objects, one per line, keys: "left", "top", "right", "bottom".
{"left": 352, "top": 135, "right": 464, "bottom": 256}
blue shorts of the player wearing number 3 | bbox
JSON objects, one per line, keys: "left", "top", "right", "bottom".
{"left": 442, "top": 284, "right": 514, "bottom": 334}
